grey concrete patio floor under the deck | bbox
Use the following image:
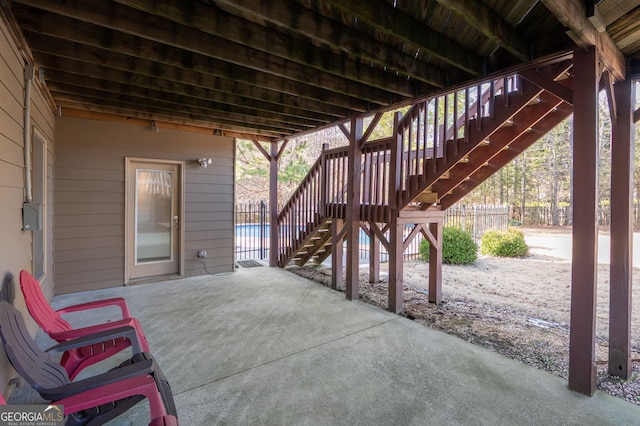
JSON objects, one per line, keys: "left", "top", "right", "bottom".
{"left": 12, "top": 267, "right": 640, "bottom": 426}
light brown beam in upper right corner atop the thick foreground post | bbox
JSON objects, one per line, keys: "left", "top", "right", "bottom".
{"left": 542, "top": 0, "right": 627, "bottom": 80}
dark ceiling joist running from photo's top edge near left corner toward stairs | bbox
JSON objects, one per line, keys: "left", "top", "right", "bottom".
{"left": 16, "top": 0, "right": 416, "bottom": 97}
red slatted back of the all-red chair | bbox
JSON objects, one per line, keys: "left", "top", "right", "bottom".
{"left": 20, "top": 270, "right": 72, "bottom": 334}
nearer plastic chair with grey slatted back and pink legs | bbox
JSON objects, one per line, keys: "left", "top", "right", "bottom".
{"left": 0, "top": 300, "right": 178, "bottom": 425}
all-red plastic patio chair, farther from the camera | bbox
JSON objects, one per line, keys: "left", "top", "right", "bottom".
{"left": 20, "top": 270, "right": 149, "bottom": 380}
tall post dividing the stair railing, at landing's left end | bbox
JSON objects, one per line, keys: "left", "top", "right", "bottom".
{"left": 346, "top": 117, "right": 364, "bottom": 300}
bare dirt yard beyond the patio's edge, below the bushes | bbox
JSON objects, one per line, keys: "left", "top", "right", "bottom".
{"left": 291, "top": 228, "right": 640, "bottom": 405}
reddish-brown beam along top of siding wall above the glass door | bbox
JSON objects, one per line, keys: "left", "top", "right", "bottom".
{"left": 61, "top": 107, "right": 274, "bottom": 142}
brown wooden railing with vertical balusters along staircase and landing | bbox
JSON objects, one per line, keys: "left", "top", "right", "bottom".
{"left": 278, "top": 76, "right": 521, "bottom": 261}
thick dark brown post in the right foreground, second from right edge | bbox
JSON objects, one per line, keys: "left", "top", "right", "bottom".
{"left": 569, "top": 47, "right": 600, "bottom": 395}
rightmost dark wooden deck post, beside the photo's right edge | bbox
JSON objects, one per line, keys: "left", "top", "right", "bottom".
{"left": 609, "top": 80, "right": 635, "bottom": 379}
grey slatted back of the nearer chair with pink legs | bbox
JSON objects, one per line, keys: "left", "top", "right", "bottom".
{"left": 0, "top": 300, "right": 71, "bottom": 391}
